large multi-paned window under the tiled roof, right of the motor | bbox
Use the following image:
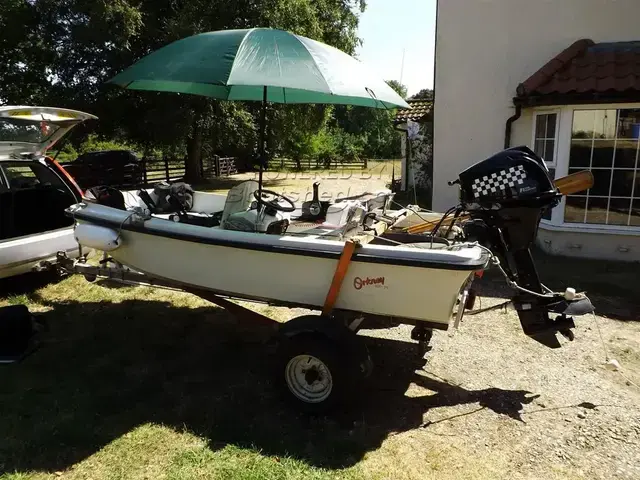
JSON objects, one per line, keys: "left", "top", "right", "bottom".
{"left": 564, "top": 109, "right": 640, "bottom": 226}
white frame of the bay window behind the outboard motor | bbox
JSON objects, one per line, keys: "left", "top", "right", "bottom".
{"left": 531, "top": 103, "right": 640, "bottom": 236}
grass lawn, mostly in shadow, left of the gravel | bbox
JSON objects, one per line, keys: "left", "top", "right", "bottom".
{"left": 0, "top": 275, "right": 380, "bottom": 480}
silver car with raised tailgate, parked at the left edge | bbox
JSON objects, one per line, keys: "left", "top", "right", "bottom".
{"left": 0, "top": 106, "right": 96, "bottom": 278}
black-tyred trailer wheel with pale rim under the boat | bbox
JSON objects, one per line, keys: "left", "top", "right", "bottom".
{"left": 276, "top": 333, "right": 371, "bottom": 413}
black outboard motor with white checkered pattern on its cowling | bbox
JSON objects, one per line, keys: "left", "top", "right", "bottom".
{"left": 454, "top": 147, "right": 594, "bottom": 348}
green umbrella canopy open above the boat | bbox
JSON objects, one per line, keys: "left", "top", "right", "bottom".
{"left": 109, "top": 28, "right": 410, "bottom": 108}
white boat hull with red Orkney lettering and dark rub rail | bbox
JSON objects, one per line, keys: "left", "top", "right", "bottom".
{"left": 70, "top": 204, "right": 486, "bottom": 324}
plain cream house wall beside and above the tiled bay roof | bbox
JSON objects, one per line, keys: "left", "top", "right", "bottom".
{"left": 433, "top": 0, "right": 640, "bottom": 211}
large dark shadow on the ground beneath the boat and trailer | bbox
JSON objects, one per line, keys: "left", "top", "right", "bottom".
{"left": 0, "top": 299, "right": 534, "bottom": 474}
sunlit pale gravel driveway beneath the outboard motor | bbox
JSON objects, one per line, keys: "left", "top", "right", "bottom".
{"left": 270, "top": 278, "right": 640, "bottom": 480}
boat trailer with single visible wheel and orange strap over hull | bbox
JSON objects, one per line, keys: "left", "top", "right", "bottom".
{"left": 51, "top": 239, "right": 460, "bottom": 413}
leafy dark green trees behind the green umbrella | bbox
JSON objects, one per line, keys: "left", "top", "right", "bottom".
{"left": 0, "top": 0, "right": 416, "bottom": 178}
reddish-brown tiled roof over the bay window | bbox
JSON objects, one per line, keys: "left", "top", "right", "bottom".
{"left": 516, "top": 39, "right": 640, "bottom": 101}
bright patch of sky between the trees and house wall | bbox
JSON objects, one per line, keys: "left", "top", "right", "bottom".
{"left": 356, "top": 0, "right": 436, "bottom": 95}
